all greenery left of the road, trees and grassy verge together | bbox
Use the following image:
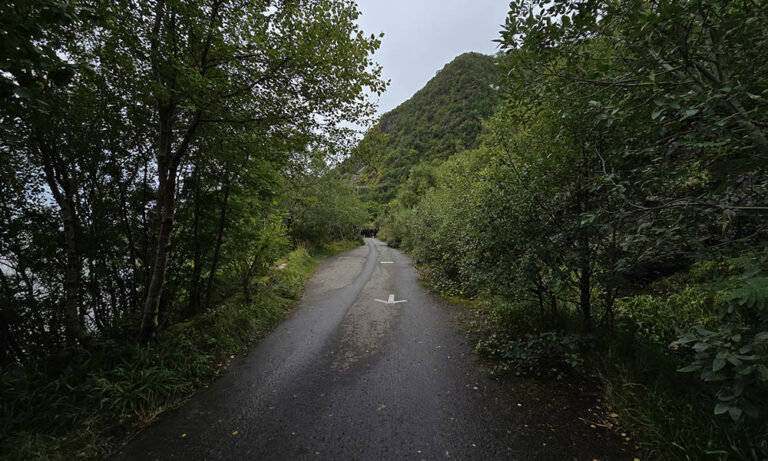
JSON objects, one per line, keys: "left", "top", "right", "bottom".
{"left": 0, "top": 0, "right": 386, "bottom": 459}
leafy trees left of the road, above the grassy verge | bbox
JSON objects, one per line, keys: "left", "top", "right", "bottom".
{"left": 0, "top": 0, "right": 384, "bottom": 363}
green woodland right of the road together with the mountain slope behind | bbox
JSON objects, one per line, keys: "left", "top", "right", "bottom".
{"left": 348, "top": 0, "right": 768, "bottom": 460}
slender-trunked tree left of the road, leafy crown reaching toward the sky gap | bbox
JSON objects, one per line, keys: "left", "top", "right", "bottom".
{"left": 94, "top": 0, "right": 383, "bottom": 342}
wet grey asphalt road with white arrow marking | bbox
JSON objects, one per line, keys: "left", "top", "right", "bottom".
{"left": 116, "top": 239, "right": 553, "bottom": 460}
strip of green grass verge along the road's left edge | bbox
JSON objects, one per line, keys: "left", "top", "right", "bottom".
{"left": 0, "top": 242, "right": 352, "bottom": 460}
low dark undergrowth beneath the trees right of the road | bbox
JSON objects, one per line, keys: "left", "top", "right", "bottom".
{"left": 456, "top": 263, "right": 768, "bottom": 461}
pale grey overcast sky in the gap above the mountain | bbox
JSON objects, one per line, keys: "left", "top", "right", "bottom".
{"left": 357, "top": 0, "right": 509, "bottom": 114}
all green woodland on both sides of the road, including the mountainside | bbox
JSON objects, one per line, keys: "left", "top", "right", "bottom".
{"left": 0, "top": 0, "right": 768, "bottom": 461}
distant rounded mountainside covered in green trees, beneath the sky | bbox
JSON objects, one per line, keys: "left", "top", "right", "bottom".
{"left": 348, "top": 53, "right": 500, "bottom": 203}
